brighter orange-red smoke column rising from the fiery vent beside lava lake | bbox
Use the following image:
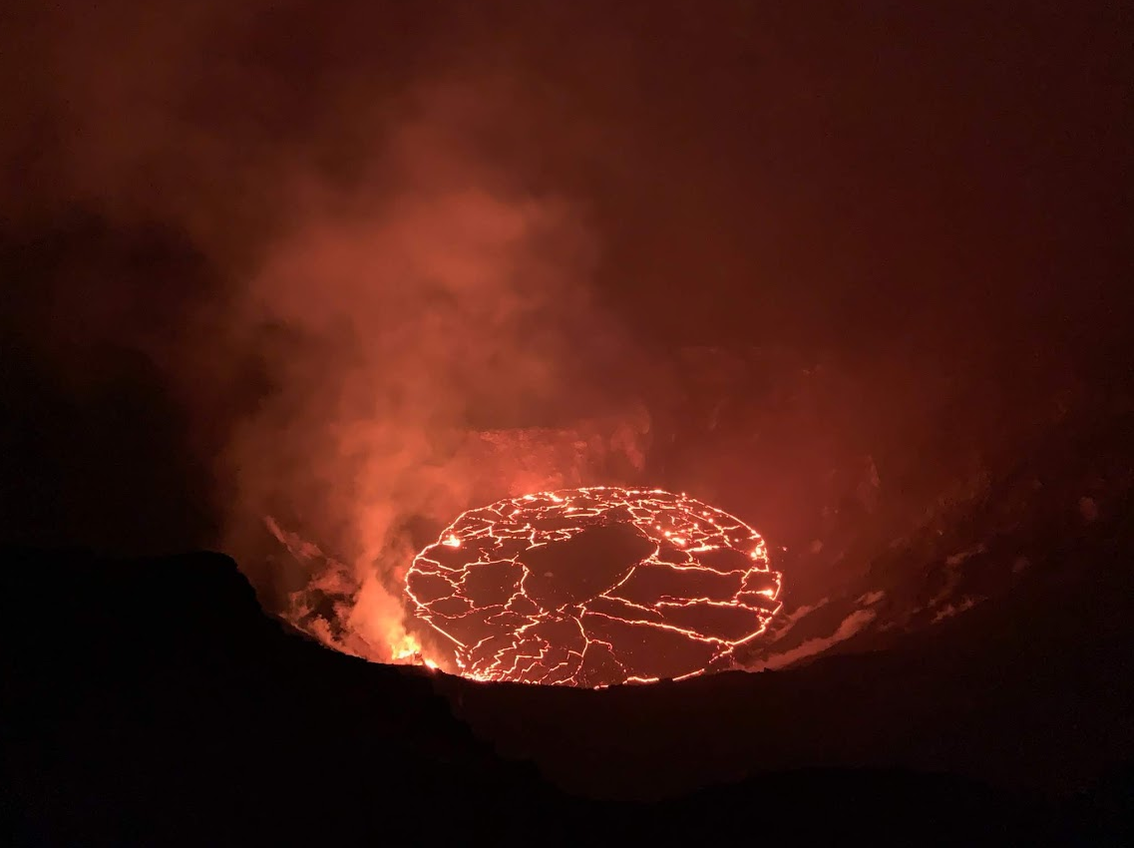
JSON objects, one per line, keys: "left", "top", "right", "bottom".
{"left": 227, "top": 87, "right": 644, "bottom": 645}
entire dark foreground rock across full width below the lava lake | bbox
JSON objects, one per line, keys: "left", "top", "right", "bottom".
{"left": 3, "top": 539, "right": 1132, "bottom": 845}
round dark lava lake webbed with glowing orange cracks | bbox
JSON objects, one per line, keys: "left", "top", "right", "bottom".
{"left": 406, "top": 487, "right": 780, "bottom": 687}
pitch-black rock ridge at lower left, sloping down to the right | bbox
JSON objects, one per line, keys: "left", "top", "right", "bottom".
{"left": 3, "top": 552, "right": 560, "bottom": 845}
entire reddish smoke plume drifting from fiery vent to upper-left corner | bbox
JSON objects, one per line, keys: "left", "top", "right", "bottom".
{"left": 0, "top": 3, "right": 649, "bottom": 659}
